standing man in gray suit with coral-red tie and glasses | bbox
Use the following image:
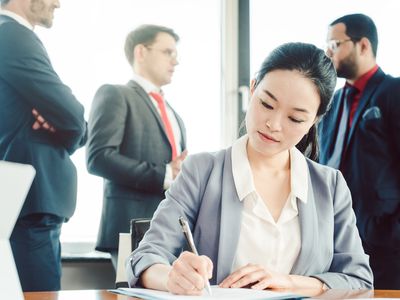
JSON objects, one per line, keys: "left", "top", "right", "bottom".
{"left": 87, "top": 25, "right": 187, "bottom": 268}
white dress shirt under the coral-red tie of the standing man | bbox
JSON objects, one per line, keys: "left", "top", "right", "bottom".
{"left": 132, "top": 73, "right": 182, "bottom": 190}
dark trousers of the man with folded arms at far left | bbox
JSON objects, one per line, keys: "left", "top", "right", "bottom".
{"left": 10, "top": 214, "right": 65, "bottom": 292}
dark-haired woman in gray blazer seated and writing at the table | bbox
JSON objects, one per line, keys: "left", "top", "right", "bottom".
{"left": 127, "top": 43, "right": 373, "bottom": 295}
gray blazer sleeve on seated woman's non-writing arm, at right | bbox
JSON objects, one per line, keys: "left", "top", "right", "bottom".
{"left": 313, "top": 171, "right": 373, "bottom": 289}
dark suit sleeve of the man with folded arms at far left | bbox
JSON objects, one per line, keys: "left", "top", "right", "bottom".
{"left": 0, "top": 22, "right": 87, "bottom": 154}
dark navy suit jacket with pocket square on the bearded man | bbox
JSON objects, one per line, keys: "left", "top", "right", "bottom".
{"left": 319, "top": 69, "right": 400, "bottom": 255}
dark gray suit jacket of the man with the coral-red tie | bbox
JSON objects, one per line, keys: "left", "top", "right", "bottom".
{"left": 87, "top": 81, "right": 186, "bottom": 250}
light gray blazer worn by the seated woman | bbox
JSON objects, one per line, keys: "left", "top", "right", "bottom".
{"left": 127, "top": 148, "right": 373, "bottom": 289}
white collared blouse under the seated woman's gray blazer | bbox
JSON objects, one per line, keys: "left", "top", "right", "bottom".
{"left": 232, "top": 135, "right": 308, "bottom": 274}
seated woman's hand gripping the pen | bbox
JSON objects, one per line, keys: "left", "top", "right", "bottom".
{"left": 167, "top": 251, "right": 213, "bottom": 295}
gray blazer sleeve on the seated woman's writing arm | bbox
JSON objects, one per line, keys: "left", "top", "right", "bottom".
{"left": 126, "top": 156, "right": 210, "bottom": 287}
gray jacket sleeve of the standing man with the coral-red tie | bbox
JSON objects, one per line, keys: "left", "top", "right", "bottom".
{"left": 86, "top": 85, "right": 166, "bottom": 193}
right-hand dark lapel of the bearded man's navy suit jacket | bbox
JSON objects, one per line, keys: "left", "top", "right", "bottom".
{"left": 345, "top": 69, "right": 385, "bottom": 148}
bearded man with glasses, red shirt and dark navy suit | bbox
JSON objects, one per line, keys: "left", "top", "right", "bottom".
{"left": 319, "top": 14, "right": 400, "bottom": 289}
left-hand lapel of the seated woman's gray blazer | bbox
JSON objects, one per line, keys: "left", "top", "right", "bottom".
{"left": 217, "top": 149, "right": 243, "bottom": 282}
